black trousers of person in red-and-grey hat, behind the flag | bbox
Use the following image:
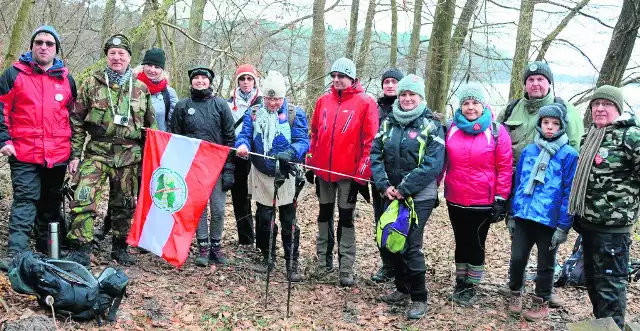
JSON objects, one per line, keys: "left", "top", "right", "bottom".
{"left": 231, "top": 157, "right": 254, "bottom": 245}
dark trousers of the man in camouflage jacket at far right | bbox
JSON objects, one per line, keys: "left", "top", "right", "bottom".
{"left": 582, "top": 229, "right": 631, "bottom": 328}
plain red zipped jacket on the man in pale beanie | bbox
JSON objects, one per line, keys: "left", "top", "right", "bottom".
{"left": 307, "top": 80, "right": 378, "bottom": 184}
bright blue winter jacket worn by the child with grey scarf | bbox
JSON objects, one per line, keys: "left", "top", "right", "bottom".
{"left": 512, "top": 144, "right": 578, "bottom": 232}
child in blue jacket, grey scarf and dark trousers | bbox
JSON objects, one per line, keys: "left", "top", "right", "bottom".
{"left": 507, "top": 103, "right": 578, "bottom": 321}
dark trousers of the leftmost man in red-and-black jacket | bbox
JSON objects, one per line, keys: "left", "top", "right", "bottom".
{"left": 7, "top": 161, "right": 67, "bottom": 256}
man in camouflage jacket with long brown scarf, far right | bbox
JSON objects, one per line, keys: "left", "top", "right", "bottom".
{"left": 569, "top": 85, "right": 640, "bottom": 328}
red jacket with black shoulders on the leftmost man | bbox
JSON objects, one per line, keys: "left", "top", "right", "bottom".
{"left": 0, "top": 53, "right": 76, "bottom": 168}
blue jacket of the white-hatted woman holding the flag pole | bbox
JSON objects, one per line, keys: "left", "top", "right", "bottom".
{"left": 236, "top": 99, "right": 309, "bottom": 177}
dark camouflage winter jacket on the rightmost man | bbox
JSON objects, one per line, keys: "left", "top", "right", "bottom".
{"left": 581, "top": 112, "right": 640, "bottom": 233}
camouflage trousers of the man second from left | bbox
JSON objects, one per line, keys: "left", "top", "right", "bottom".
{"left": 67, "top": 159, "right": 139, "bottom": 244}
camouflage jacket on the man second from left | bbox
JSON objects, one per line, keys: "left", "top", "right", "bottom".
{"left": 71, "top": 70, "right": 158, "bottom": 167}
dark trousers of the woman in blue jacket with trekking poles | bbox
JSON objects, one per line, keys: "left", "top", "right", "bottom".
{"left": 256, "top": 203, "right": 300, "bottom": 262}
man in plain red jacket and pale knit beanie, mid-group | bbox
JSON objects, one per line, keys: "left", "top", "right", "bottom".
{"left": 306, "top": 58, "right": 378, "bottom": 286}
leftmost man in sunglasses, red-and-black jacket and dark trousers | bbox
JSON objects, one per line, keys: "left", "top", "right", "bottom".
{"left": 0, "top": 26, "right": 76, "bottom": 269}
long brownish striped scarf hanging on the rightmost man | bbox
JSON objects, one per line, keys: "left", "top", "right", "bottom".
{"left": 568, "top": 126, "right": 607, "bottom": 216}
